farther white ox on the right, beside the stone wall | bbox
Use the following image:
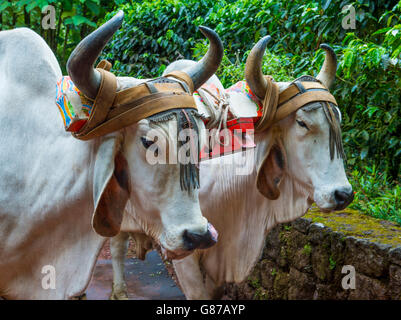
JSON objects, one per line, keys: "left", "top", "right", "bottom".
{"left": 111, "top": 37, "right": 353, "bottom": 299}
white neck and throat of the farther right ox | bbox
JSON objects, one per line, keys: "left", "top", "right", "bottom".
{"left": 200, "top": 133, "right": 310, "bottom": 284}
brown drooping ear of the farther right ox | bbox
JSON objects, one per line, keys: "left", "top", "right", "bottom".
{"left": 256, "top": 140, "right": 287, "bottom": 200}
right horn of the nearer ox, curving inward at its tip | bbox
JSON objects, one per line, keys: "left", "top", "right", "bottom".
{"left": 183, "top": 26, "right": 224, "bottom": 91}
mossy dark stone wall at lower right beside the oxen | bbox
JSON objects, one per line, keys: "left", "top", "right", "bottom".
{"left": 225, "top": 209, "right": 401, "bottom": 300}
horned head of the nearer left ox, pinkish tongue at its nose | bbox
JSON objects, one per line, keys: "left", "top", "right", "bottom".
{"left": 67, "top": 11, "right": 223, "bottom": 259}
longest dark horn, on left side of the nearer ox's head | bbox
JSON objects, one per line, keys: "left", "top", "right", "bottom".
{"left": 67, "top": 10, "right": 124, "bottom": 99}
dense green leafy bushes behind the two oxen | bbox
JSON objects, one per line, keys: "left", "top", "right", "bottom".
{"left": 0, "top": 0, "right": 401, "bottom": 224}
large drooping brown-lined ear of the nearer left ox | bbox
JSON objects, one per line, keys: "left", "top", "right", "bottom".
{"left": 92, "top": 134, "right": 130, "bottom": 237}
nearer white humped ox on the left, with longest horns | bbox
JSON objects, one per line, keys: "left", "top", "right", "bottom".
{"left": 0, "top": 12, "right": 222, "bottom": 299}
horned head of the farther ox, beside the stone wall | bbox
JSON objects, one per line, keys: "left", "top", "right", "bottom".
{"left": 245, "top": 36, "right": 353, "bottom": 212}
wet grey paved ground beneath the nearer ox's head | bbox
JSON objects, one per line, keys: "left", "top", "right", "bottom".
{"left": 86, "top": 243, "right": 185, "bottom": 300}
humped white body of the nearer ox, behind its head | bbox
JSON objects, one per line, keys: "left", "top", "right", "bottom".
{"left": 0, "top": 28, "right": 104, "bottom": 299}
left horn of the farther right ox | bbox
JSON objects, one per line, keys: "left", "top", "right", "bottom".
{"left": 245, "top": 36, "right": 271, "bottom": 100}
